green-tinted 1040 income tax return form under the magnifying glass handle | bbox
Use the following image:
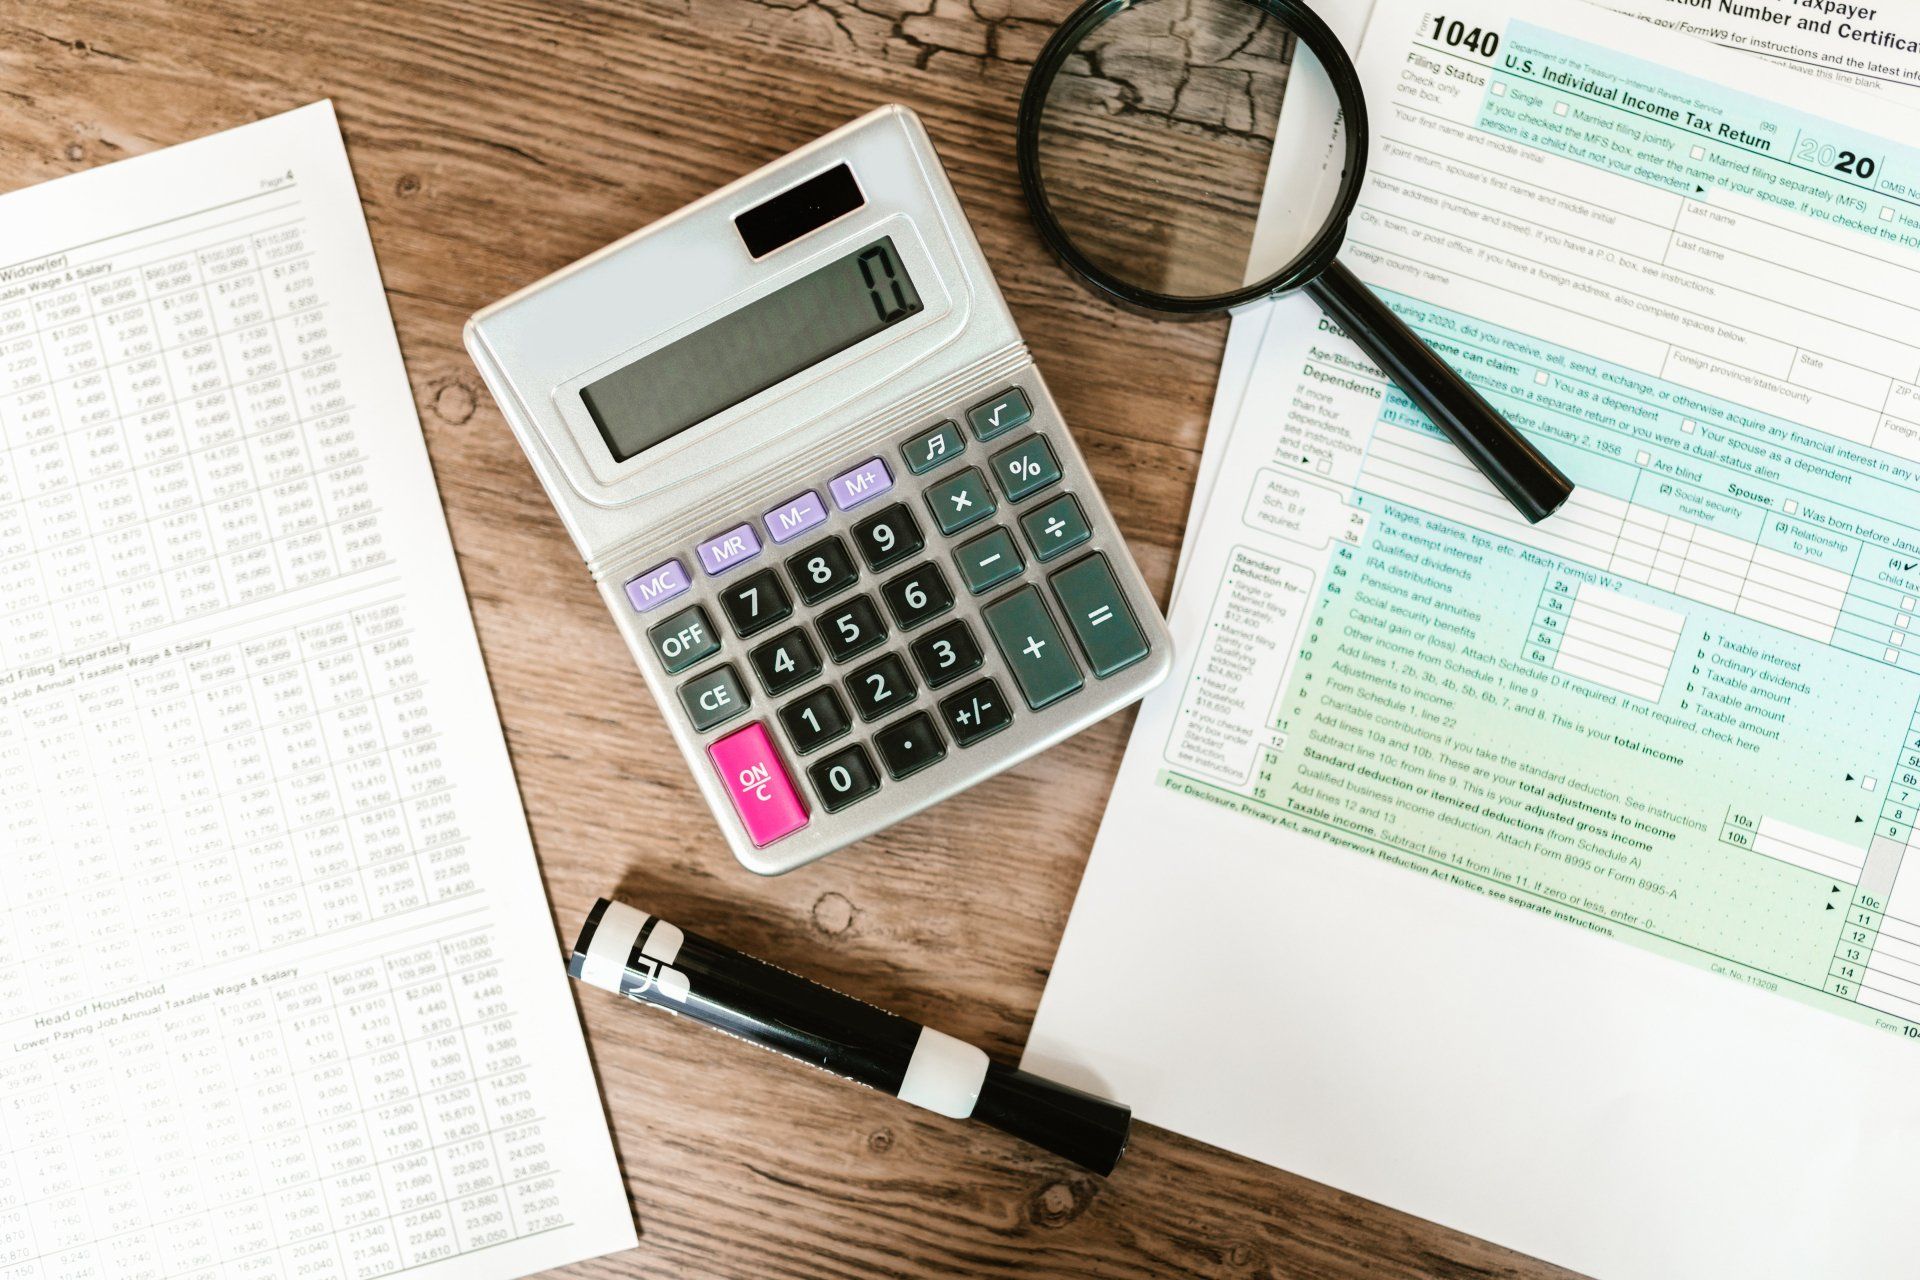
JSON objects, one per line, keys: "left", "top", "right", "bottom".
{"left": 1027, "top": 0, "right": 1920, "bottom": 1276}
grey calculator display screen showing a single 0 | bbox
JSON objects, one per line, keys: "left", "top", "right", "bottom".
{"left": 580, "top": 236, "right": 920, "bottom": 462}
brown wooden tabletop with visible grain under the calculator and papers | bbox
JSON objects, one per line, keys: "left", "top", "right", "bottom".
{"left": 0, "top": 0, "right": 1565, "bottom": 1280}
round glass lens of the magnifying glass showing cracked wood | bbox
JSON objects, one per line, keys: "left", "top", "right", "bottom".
{"left": 1035, "top": 0, "right": 1346, "bottom": 299}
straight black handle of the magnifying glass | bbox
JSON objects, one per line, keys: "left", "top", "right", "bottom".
{"left": 1304, "top": 259, "right": 1572, "bottom": 524}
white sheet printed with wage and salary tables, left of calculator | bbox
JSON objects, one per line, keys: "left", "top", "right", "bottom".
{"left": 0, "top": 104, "right": 634, "bottom": 1280}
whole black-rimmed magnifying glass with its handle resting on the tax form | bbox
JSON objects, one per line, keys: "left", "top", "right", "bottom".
{"left": 1020, "top": 0, "right": 1572, "bottom": 522}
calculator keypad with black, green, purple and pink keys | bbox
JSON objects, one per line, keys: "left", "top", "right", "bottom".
{"left": 626, "top": 379, "right": 1150, "bottom": 859}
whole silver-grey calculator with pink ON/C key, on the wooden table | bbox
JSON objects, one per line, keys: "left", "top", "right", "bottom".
{"left": 467, "top": 106, "right": 1171, "bottom": 875}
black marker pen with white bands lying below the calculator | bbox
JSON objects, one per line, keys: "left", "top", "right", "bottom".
{"left": 566, "top": 898, "right": 1133, "bottom": 1174}
